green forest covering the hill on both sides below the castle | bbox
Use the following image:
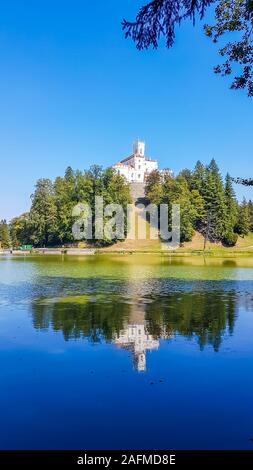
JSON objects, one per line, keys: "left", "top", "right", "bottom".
{"left": 0, "top": 160, "right": 253, "bottom": 248}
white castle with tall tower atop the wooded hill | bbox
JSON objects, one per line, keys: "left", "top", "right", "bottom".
{"left": 113, "top": 140, "right": 158, "bottom": 183}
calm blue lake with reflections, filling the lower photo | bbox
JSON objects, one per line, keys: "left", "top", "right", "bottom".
{"left": 0, "top": 255, "right": 253, "bottom": 449}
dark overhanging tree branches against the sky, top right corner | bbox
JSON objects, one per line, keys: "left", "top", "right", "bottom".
{"left": 122, "top": 0, "right": 253, "bottom": 96}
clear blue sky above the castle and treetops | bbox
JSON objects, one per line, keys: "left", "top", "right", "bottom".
{"left": 0, "top": 0, "right": 253, "bottom": 219}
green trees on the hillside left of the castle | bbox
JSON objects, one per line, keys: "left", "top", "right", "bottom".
{"left": 0, "top": 165, "right": 132, "bottom": 248}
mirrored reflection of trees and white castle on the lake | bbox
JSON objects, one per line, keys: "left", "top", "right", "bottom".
{"left": 32, "top": 291, "right": 238, "bottom": 371}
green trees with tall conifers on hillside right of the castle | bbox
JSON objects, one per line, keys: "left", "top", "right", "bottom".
{"left": 146, "top": 160, "right": 253, "bottom": 246}
